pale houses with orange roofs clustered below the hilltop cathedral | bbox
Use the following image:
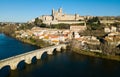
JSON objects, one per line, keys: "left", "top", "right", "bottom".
{"left": 15, "top": 25, "right": 120, "bottom": 52}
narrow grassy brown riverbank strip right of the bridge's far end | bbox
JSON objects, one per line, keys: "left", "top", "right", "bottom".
{"left": 72, "top": 48, "right": 120, "bottom": 61}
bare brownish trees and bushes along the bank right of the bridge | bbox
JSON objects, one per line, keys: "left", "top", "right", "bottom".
{"left": 69, "top": 40, "right": 120, "bottom": 61}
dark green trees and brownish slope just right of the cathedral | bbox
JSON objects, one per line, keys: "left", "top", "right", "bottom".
{"left": 80, "top": 17, "right": 105, "bottom": 37}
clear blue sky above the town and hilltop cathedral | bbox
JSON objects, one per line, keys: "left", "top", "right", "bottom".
{"left": 0, "top": 0, "right": 120, "bottom": 22}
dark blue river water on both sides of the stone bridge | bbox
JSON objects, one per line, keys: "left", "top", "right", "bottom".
{"left": 0, "top": 34, "right": 120, "bottom": 77}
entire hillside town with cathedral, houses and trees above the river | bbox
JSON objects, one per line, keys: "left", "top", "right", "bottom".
{"left": 0, "top": 8, "right": 120, "bottom": 60}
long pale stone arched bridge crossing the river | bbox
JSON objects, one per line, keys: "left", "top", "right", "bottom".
{"left": 0, "top": 44, "right": 66, "bottom": 70}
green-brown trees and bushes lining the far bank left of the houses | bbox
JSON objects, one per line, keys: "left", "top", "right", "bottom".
{"left": 0, "top": 24, "right": 50, "bottom": 48}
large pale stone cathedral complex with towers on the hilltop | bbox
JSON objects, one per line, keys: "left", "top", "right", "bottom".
{"left": 29, "top": 8, "right": 90, "bottom": 25}
